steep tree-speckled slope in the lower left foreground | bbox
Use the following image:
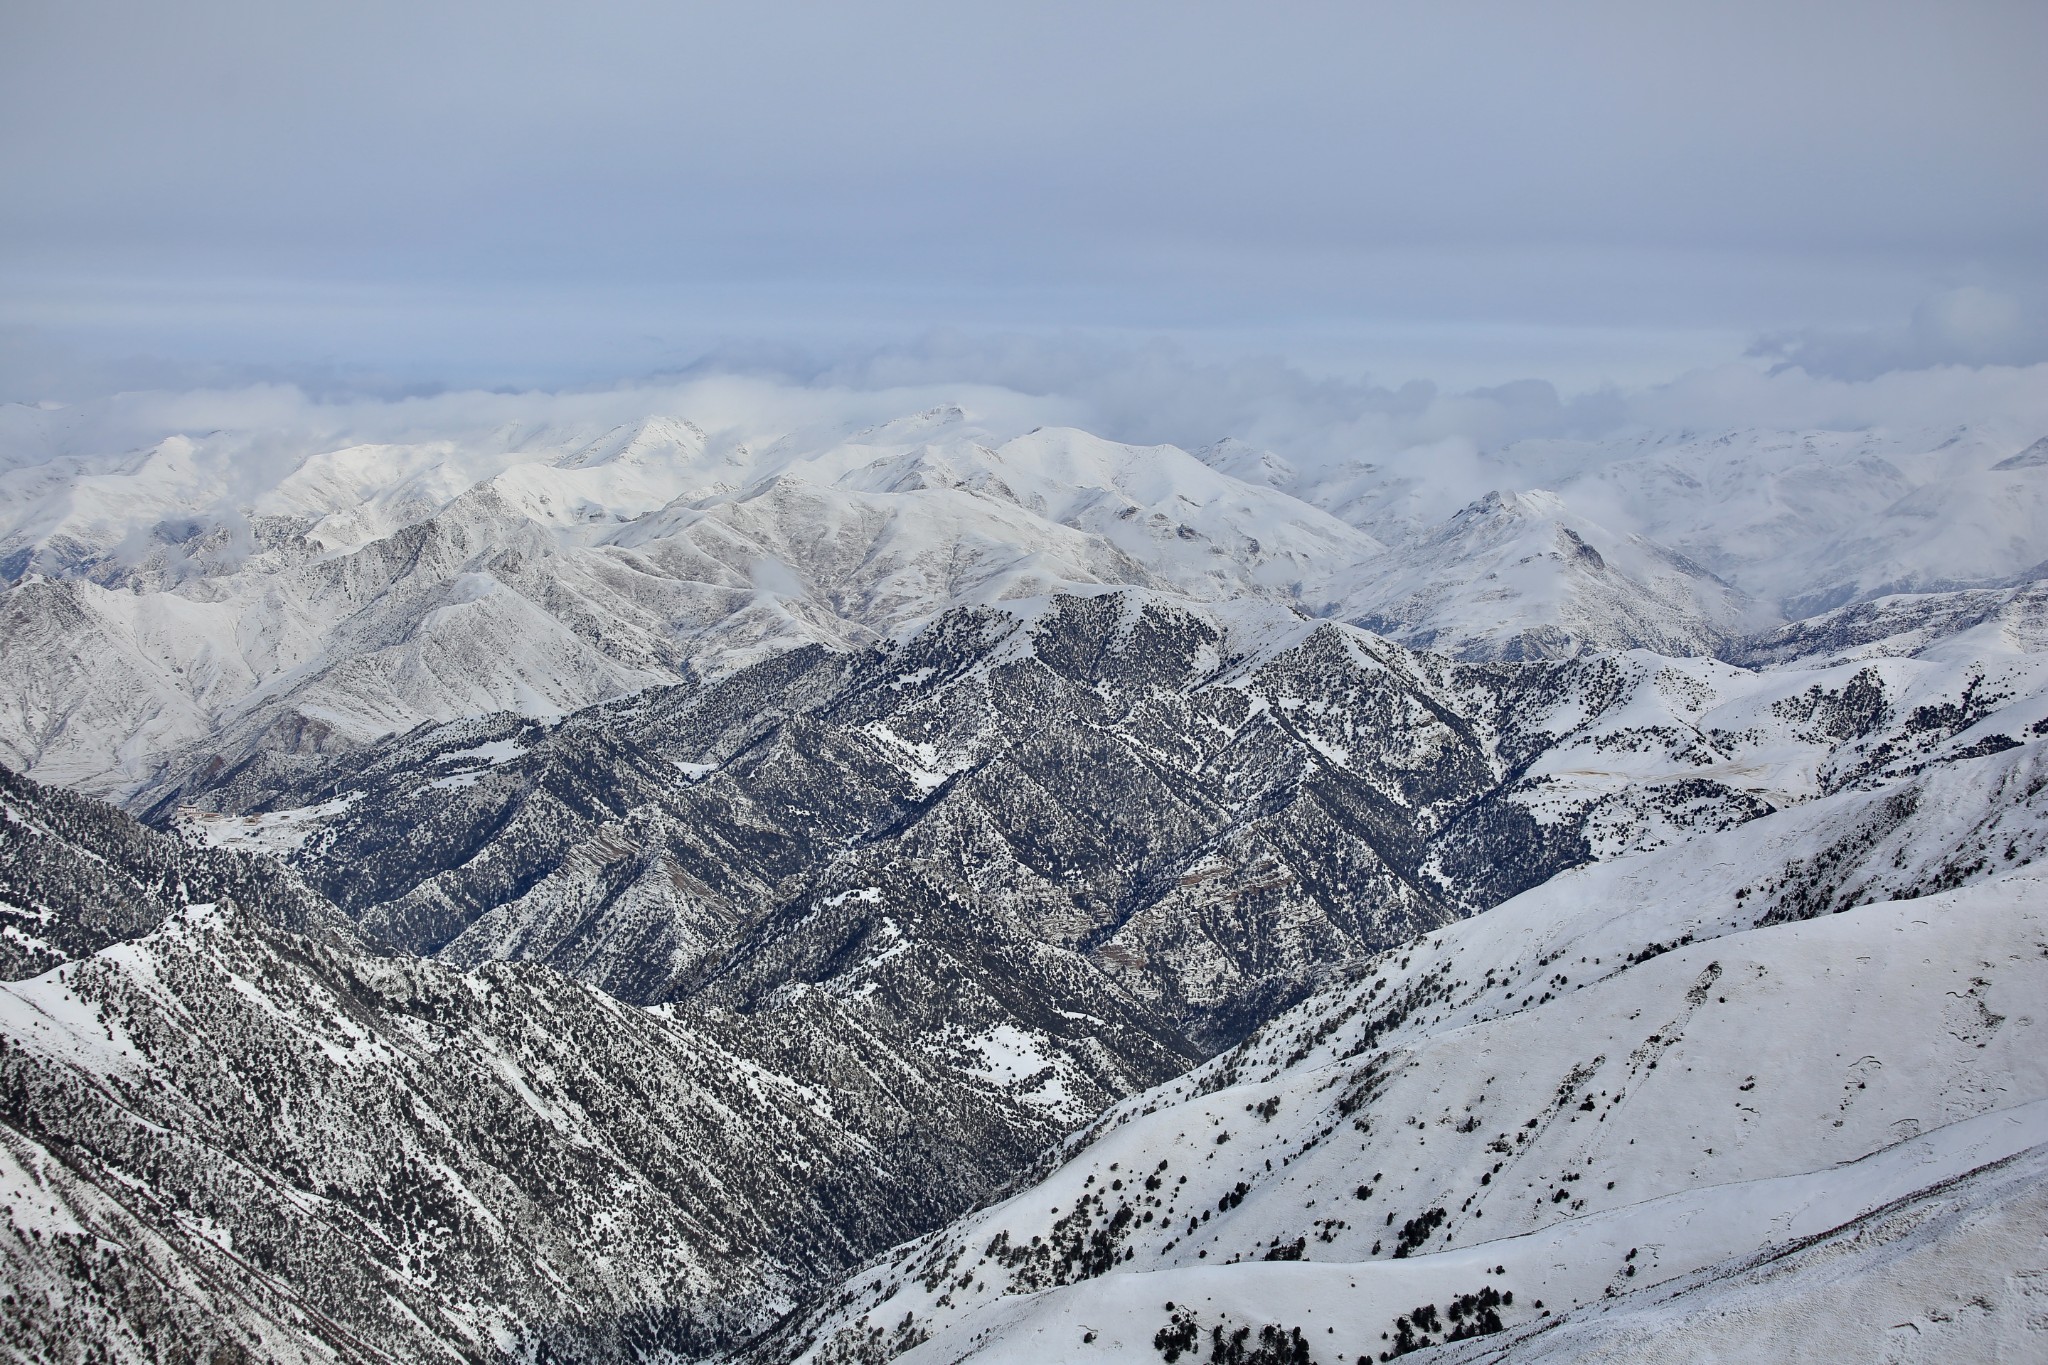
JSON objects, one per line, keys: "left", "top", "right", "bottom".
{"left": 0, "top": 778, "right": 1138, "bottom": 1361}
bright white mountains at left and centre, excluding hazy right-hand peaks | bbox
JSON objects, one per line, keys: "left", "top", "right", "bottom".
{"left": 0, "top": 409, "right": 1380, "bottom": 794}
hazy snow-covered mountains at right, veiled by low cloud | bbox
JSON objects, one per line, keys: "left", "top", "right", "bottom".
{"left": 1202, "top": 422, "right": 2048, "bottom": 639}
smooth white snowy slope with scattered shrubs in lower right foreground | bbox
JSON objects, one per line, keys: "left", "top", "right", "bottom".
{"left": 782, "top": 741, "right": 2048, "bottom": 1365}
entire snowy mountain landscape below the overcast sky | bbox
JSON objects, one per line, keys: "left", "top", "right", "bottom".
{"left": 0, "top": 391, "right": 2048, "bottom": 1365}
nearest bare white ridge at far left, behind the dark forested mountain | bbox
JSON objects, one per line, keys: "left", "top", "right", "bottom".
{"left": 0, "top": 493, "right": 680, "bottom": 792}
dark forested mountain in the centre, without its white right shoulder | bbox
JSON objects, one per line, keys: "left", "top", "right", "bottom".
{"left": 176, "top": 593, "right": 1495, "bottom": 1036}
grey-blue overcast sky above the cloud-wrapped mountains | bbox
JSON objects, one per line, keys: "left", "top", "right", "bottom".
{"left": 0, "top": 0, "right": 2048, "bottom": 399}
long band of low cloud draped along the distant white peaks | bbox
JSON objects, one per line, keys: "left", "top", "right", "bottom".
{"left": 12, "top": 323, "right": 2048, "bottom": 511}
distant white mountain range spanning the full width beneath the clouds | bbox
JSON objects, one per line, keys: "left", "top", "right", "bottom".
{"left": 0, "top": 407, "right": 2048, "bottom": 796}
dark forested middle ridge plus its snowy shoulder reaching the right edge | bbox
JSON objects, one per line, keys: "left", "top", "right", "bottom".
{"left": 158, "top": 591, "right": 2048, "bottom": 998}
